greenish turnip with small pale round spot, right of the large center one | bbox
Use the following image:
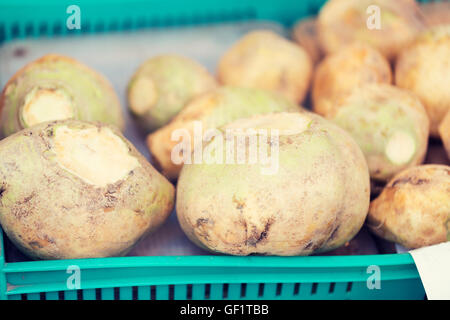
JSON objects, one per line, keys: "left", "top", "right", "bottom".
{"left": 329, "top": 84, "right": 429, "bottom": 181}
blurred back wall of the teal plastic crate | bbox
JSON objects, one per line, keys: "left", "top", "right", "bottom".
{"left": 0, "top": 0, "right": 325, "bottom": 43}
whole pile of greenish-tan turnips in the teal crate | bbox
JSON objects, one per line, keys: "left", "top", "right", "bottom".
{"left": 0, "top": 0, "right": 450, "bottom": 259}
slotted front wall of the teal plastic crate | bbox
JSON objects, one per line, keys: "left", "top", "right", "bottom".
{"left": 0, "top": 228, "right": 425, "bottom": 300}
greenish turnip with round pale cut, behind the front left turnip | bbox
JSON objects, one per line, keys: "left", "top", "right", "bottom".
{"left": 0, "top": 54, "right": 124, "bottom": 136}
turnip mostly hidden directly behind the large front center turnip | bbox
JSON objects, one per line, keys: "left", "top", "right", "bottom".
{"left": 147, "top": 87, "right": 302, "bottom": 179}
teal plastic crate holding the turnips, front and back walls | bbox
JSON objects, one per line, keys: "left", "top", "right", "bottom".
{"left": 0, "top": 0, "right": 432, "bottom": 300}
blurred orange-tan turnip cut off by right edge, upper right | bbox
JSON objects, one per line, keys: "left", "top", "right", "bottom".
{"left": 395, "top": 25, "right": 450, "bottom": 137}
